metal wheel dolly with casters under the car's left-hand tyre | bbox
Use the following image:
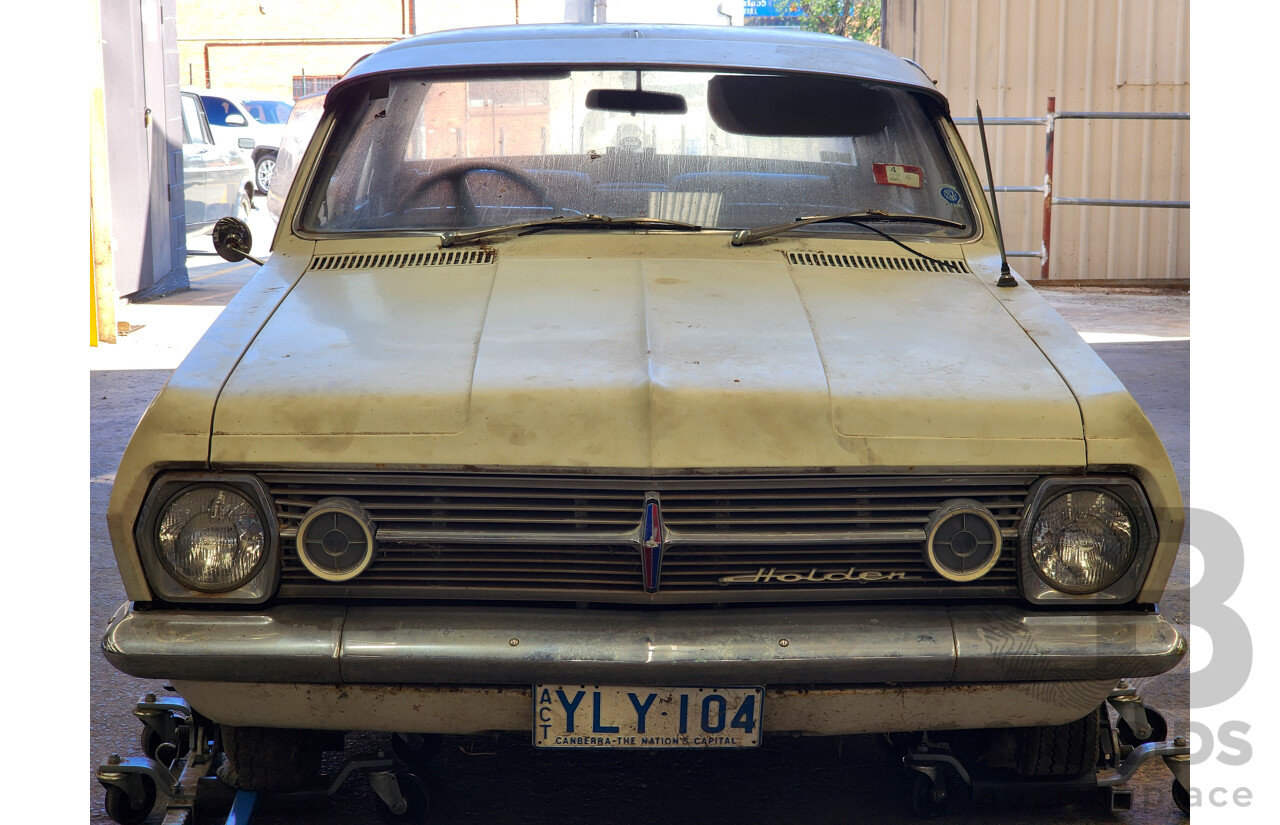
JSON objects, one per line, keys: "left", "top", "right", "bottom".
{"left": 96, "top": 693, "right": 429, "bottom": 825}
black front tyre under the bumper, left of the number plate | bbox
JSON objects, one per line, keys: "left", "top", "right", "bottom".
{"left": 218, "top": 725, "right": 321, "bottom": 790}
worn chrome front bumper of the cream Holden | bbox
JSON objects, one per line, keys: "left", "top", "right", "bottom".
{"left": 102, "top": 604, "right": 1187, "bottom": 684}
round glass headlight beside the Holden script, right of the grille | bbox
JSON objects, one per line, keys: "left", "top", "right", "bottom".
{"left": 1030, "top": 490, "right": 1138, "bottom": 593}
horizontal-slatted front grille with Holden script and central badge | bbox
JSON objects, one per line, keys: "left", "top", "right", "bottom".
{"left": 259, "top": 472, "right": 1034, "bottom": 604}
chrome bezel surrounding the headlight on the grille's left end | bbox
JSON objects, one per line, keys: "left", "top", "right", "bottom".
{"left": 133, "top": 472, "right": 280, "bottom": 604}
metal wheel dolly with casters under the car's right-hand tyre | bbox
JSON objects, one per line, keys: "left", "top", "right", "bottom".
{"left": 902, "top": 682, "right": 1190, "bottom": 819}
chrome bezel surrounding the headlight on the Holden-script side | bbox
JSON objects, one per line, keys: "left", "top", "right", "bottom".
{"left": 1018, "top": 476, "right": 1160, "bottom": 604}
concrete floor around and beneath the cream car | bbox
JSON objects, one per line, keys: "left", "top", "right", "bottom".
{"left": 87, "top": 235, "right": 1190, "bottom": 825}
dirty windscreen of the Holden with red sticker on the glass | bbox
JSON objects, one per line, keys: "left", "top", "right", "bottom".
{"left": 301, "top": 70, "right": 975, "bottom": 237}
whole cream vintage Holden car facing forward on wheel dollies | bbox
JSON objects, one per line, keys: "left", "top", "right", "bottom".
{"left": 102, "top": 26, "right": 1185, "bottom": 807}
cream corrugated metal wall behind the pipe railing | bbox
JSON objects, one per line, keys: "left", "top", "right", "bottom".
{"left": 883, "top": 0, "right": 1190, "bottom": 281}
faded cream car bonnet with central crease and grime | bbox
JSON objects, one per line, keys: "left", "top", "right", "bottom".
{"left": 210, "top": 235, "right": 1084, "bottom": 468}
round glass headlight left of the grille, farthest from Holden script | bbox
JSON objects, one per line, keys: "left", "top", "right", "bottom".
{"left": 156, "top": 486, "right": 266, "bottom": 593}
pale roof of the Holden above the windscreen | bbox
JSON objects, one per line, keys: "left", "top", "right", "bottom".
{"left": 330, "top": 23, "right": 942, "bottom": 100}
